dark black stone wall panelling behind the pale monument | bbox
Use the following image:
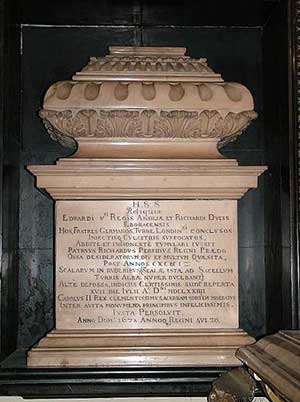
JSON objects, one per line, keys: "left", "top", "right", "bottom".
{"left": 0, "top": 0, "right": 299, "bottom": 396}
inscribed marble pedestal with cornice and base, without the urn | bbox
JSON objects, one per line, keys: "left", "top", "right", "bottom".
{"left": 28, "top": 159, "right": 264, "bottom": 367}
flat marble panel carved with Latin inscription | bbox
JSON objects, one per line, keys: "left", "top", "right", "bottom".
{"left": 56, "top": 200, "right": 239, "bottom": 330}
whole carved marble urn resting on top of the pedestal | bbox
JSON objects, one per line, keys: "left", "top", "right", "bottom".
{"left": 40, "top": 47, "right": 257, "bottom": 159}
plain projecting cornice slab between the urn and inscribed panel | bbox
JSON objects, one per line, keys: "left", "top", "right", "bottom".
{"left": 28, "top": 159, "right": 266, "bottom": 200}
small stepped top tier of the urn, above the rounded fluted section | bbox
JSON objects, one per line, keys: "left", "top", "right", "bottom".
{"left": 73, "top": 46, "right": 223, "bottom": 82}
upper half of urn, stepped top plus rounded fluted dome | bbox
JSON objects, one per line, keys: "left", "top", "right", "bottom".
{"left": 44, "top": 47, "right": 254, "bottom": 117}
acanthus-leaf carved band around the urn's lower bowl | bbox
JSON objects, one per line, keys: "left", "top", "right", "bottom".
{"left": 40, "top": 109, "right": 257, "bottom": 147}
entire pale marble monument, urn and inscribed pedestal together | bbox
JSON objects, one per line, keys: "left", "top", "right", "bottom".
{"left": 28, "top": 47, "right": 265, "bottom": 367}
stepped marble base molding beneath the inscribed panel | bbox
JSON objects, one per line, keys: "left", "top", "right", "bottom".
{"left": 27, "top": 329, "right": 255, "bottom": 367}
